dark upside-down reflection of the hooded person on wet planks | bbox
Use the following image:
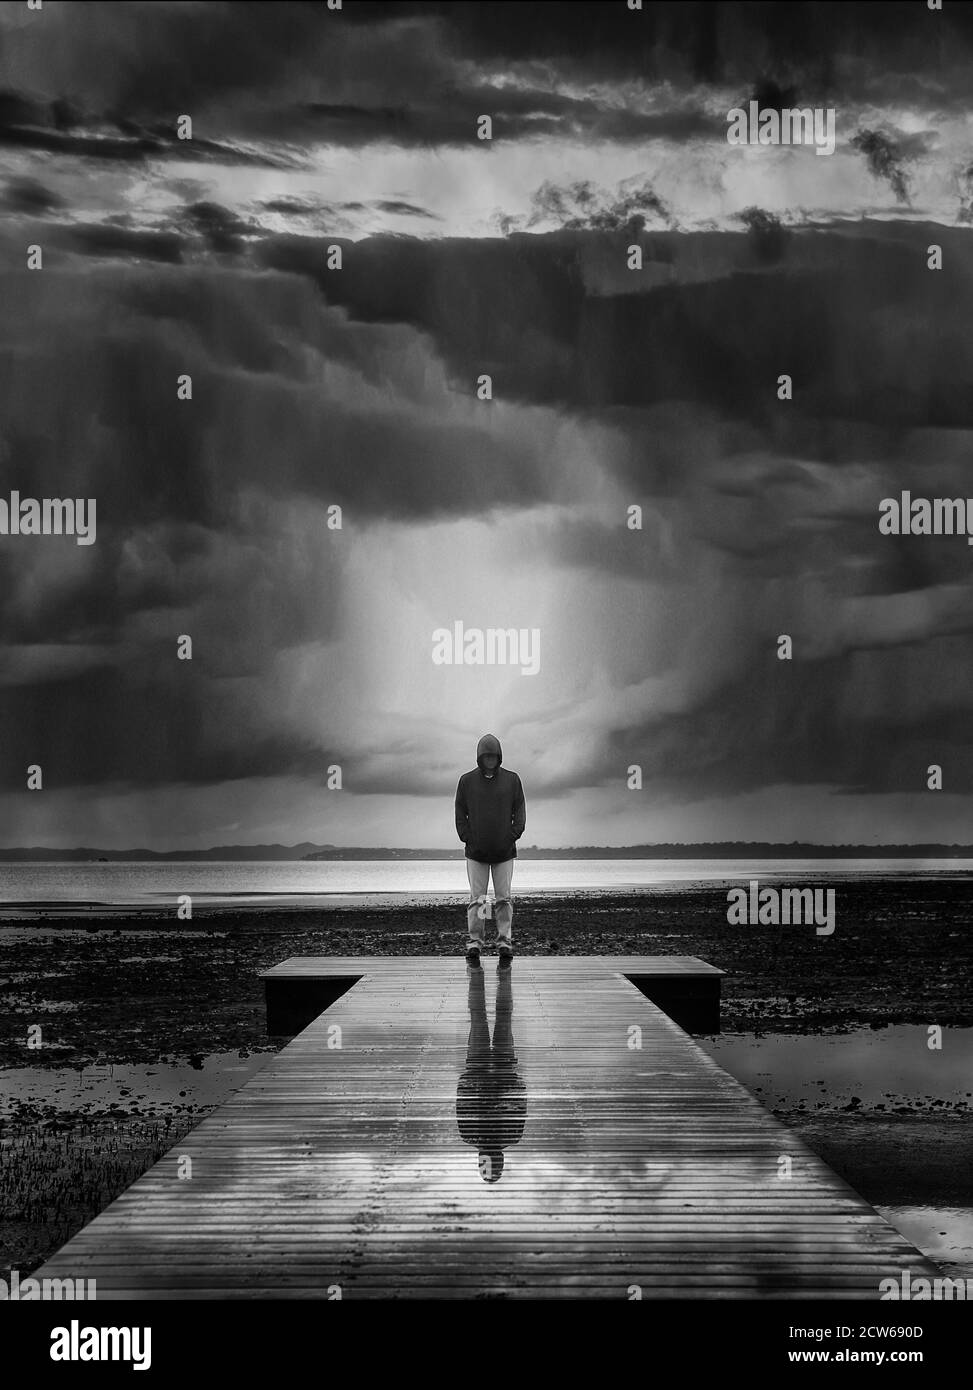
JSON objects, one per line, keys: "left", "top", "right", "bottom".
{"left": 456, "top": 960, "right": 527, "bottom": 1183}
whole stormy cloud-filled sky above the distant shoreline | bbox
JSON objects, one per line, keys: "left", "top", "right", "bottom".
{"left": 0, "top": 0, "right": 973, "bottom": 849}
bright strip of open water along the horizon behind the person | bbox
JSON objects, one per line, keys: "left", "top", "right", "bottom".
{"left": 0, "top": 855, "right": 973, "bottom": 916}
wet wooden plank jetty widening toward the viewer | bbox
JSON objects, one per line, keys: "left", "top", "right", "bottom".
{"left": 36, "top": 955, "right": 938, "bottom": 1300}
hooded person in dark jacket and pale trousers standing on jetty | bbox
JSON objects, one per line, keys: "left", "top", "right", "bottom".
{"left": 456, "top": 734, "right": 527, "bottom": 965}
